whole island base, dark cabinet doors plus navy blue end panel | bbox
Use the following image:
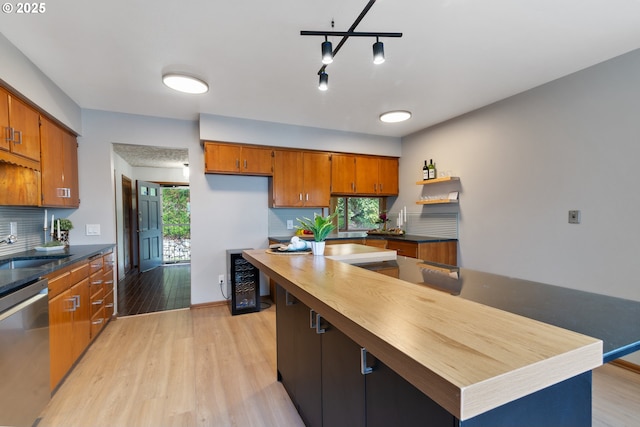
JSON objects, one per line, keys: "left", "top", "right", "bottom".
{"left": 276, "top": 285, "right": 592, "bottom": 427}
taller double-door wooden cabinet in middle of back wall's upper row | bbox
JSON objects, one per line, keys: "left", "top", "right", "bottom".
{"left": 269, "top": 150, "right": 331, "bottom": 208}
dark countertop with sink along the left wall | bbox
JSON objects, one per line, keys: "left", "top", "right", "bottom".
{"left": 0, "top": 244, "right": 115, "bottom": 296}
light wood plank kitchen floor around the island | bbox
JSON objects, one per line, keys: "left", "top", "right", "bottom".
{"left": 38, "top": 306, "right": 640, "bottom": 427}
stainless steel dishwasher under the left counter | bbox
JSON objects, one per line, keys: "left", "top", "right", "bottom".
{"left": 0, "top": 279, "right": 51, "bottom": 426}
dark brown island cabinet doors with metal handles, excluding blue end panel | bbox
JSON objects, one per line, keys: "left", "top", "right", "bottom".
{"left": 276, "top": 286, "right": 457, "bottom": 427}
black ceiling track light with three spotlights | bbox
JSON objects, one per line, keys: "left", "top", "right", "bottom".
{"left": 300, "top": 0, "right": 402, "bottom": 90}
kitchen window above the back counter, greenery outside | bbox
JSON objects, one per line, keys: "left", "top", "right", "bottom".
{"left": 331, "top": 197, "right": 386, "bottom": 231}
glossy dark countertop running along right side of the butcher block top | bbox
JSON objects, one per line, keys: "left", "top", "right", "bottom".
{"left": 360, "top": 257, "right": 640, "bottom": 363}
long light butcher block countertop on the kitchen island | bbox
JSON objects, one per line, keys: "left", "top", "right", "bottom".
{"left": 243, "top": 245, "right": 602, "bottom": 420}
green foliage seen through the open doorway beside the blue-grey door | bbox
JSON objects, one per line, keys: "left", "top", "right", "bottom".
{"left": 162, "top": 187, "right": 191, "bottom": 239}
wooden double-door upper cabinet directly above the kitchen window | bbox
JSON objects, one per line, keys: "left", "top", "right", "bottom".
{"left": 331, "top": 154, "right": 398, "bottom": 196}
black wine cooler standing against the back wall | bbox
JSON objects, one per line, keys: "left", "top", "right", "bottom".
{"left": 227, "top": 249, "right": 260, "bottom": 316}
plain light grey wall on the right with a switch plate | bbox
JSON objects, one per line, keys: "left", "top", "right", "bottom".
{"left": 399, "top": 51, "right": 640, "bottom": 301}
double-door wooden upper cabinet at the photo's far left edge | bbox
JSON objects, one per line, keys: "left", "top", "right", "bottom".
{"left": 0, "top": 88, "right": 40, "bottom": 170}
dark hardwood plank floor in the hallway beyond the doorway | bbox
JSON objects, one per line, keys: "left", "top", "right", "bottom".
{"left": 118, "top": 264, "right": 191, "bottom": 316}
